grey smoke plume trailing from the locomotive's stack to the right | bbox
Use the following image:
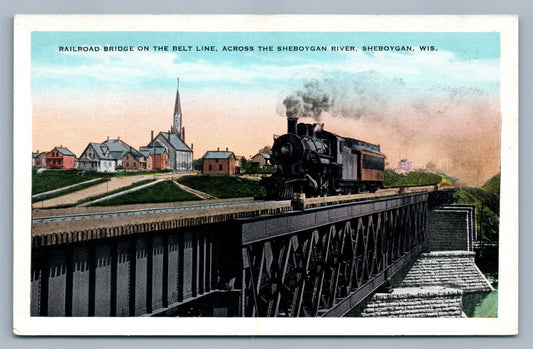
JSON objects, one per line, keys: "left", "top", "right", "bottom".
{"left": 278, "top": 72, "right": 500, "bottom": 185}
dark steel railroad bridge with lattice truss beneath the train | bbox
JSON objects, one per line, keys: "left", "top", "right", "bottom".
{"left": 31, "top": 186, "right": 486, "bottom": 317}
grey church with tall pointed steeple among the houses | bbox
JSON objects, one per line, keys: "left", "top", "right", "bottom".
{"left": 143, "top": 78, "right": 193, "bottom": 172}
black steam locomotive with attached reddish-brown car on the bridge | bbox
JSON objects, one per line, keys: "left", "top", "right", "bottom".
{"left": 261, "top": 118, "right": 385, "bottom": 199}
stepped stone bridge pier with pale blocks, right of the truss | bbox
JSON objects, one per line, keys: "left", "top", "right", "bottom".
{"left": 350, "top": 205, "right": 494, "bottom": 317}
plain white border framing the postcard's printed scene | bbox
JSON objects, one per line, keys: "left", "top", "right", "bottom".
{"left": 13, "top": 15, "right": 518, "bottom": 335}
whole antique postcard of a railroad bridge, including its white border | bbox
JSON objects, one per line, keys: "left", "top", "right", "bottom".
{"left": 13, "top": 15, "right": 518, "bottom": 335}
